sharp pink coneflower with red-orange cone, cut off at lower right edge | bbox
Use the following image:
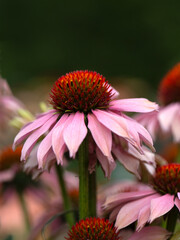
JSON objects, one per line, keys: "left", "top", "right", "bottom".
{"left": 104, "top": 164, "right": 180, "bottom": 230}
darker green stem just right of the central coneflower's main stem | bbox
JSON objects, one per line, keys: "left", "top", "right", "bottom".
{"left": 89, "top": 171, "right": 97, "bottom": 217}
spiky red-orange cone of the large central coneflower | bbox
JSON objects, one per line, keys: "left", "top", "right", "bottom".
{"left": 50, "top": 71, "right": 113, "bottom": 113}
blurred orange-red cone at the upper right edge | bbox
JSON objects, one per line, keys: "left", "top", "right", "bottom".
{"left": 159, "top": 63, "right": 180, "bottom": 105}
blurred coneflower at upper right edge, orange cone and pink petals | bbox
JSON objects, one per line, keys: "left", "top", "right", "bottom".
{"left": 136, "top": 63, "right": 180, "bottom": 142}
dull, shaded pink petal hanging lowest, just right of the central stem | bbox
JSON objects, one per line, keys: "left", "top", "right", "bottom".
{"left": 96, "top": 147, "right": 116, "bottom": 178}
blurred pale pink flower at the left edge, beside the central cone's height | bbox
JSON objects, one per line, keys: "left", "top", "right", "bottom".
{"left": 0, "top": 78, "right": 23, "bottom": 128}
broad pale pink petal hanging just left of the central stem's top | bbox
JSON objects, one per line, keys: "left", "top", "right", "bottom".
{"left": 63, "top": 112, "right": 87, "bottom": 158}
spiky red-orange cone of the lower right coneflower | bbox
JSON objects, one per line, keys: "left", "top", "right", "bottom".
{"left": 153, "top": 163, "right": 180, "bottom": 195}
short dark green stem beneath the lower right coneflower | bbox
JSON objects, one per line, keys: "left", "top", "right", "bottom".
{"left": 166, "top": 207, "right": 179, "bottom": 233}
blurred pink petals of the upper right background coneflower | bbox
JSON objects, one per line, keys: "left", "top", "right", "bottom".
{"left": 135, "top": 102, "right": 180, "bottom": 142}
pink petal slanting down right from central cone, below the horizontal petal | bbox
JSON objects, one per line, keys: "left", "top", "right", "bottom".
{"left": 92, "top": 109, "right": 130, "bottom": 139}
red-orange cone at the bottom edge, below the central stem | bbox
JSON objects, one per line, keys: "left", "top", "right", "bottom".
{"left": 65, "top": 218, "right": 120, "bottom": 240}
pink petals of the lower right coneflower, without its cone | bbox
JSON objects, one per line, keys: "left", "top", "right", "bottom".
{"left": 104, "top": 183, "right": 180, "bottom": 231}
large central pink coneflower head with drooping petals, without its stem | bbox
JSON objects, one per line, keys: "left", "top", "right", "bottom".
{"left": 14, "top": 71, "right": 157, "bottom": 175}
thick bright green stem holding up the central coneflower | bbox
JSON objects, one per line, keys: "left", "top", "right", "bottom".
{"left": 78, "top": 137, "right": 91, "bottom": 220}
